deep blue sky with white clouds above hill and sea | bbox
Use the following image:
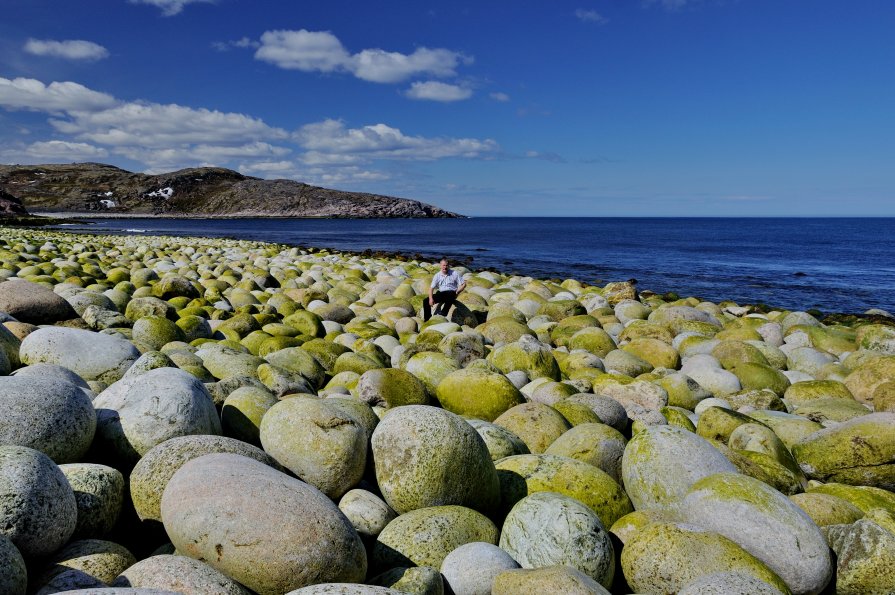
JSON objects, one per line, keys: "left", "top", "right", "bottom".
{"left": 0, "top": 0, "right": 895, "bottom": 216}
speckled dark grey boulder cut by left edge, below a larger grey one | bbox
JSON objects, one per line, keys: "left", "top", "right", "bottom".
{"left": 0, "top": 446, "right": 78, "bottom": 556}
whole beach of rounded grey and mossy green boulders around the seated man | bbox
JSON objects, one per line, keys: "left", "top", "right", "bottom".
{"left": 0, "top": 228, "right": 895, "bottom": 595}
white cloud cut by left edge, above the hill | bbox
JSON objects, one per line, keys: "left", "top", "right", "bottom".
{"left": 0, "top": 77, "right": 116, "bottom": 113}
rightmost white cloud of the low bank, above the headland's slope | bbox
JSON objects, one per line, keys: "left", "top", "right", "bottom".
{"left": 296, "top": 120, "right": 499, "bottom": 161}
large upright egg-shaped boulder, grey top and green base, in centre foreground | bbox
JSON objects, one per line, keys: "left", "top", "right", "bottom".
{"left": 372, "top": 405, "right": 500, "bottom": 514}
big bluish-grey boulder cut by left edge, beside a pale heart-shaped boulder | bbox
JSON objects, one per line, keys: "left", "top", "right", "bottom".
{"left": 0, "top": 375, "right": 96, "bottom": 464}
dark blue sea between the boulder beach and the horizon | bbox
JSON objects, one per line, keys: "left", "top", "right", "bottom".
{"left": 54, "top": 217, "right": 895, "bottom": 313}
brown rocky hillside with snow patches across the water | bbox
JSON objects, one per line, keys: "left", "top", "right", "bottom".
{"left": 0, "top": 163, "right": 462, "bottom": 218}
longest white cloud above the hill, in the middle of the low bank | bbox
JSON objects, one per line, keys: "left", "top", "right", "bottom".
{"left": 50, "top": 102, "right": 287, "bottom": 148}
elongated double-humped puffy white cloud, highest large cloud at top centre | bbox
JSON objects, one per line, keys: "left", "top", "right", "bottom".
{"left": 255, "top": 29, "right": 472, "bottom": 83}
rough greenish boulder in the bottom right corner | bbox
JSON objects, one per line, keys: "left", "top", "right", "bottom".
{"left": 824, "top": 519, "right": 895, "bottom": 595}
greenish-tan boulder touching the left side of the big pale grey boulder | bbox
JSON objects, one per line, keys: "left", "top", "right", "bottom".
{"left": 544, "top": 423, "right": 627, "bottom": 483}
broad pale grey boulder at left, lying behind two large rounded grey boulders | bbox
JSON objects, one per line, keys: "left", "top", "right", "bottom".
{"left": 19, "top": 326, "right": 140, "bottom": 383}
